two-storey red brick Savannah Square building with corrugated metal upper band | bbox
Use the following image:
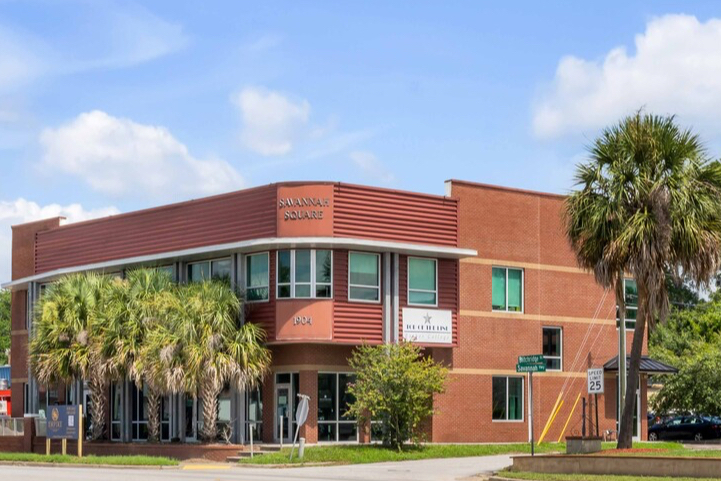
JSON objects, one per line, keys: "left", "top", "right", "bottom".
{"left": 7, "top": 181, "right": 664, "bottom": 442}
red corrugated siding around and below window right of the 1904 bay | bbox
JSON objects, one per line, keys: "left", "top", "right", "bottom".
{"left": 333, "top": 251, "right": 385, "bottom": 344}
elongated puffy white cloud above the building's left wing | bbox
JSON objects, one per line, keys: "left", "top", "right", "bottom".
{"left": 40, "top": 110, "right": 244, "bottom": 199}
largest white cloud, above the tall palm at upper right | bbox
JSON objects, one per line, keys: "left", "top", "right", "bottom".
{"left": 533, "top": 15, "right": 721, "bottom": 138}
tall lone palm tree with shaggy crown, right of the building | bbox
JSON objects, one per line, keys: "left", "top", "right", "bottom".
{"left": 565, "top": 111, "right": 721, "bottom": 448}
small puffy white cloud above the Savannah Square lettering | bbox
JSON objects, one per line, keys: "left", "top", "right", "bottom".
{"left": 231, "top": 87, "right": 310, "bottom": 156}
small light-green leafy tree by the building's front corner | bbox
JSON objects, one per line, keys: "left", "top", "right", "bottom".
{"left": 347, "top": 342, "right": 448, "bottom": 451}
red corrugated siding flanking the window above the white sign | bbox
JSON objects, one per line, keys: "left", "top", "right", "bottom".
{"left": 398, "top": 256, "right": 459, "bottom": 346}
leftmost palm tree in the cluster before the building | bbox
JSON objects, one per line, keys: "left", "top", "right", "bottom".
{"left": 30, "top": 273, "right": 109, "bottom": 439}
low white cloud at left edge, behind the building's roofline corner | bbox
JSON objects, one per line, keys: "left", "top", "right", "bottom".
{"left": 0, "top": 198, "right": 119, "bottom": 282}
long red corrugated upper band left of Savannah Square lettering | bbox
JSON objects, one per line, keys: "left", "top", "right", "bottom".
{"left": 35, "top": 185, "right": 276, "bottom": 273}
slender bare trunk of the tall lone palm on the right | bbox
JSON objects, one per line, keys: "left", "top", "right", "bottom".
{"left": 617, "top": 280, "right": 650, "bottom": 449}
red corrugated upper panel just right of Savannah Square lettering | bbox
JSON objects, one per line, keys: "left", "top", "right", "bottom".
{"left": 333, "top": 184, "right": 458, "bottom": 247}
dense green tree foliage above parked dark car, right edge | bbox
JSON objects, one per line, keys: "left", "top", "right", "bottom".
{"left": 649, "top": 292, "right": 721, "bottom": 415}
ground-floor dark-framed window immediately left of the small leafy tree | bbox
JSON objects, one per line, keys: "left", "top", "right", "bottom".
{"left": 318, "top": 373, "right": 358, "bottom": 442}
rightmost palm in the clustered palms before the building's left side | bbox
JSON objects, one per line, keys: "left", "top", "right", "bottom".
{"left": 155, "top": 281, "right": 270, "bottom": 441}
